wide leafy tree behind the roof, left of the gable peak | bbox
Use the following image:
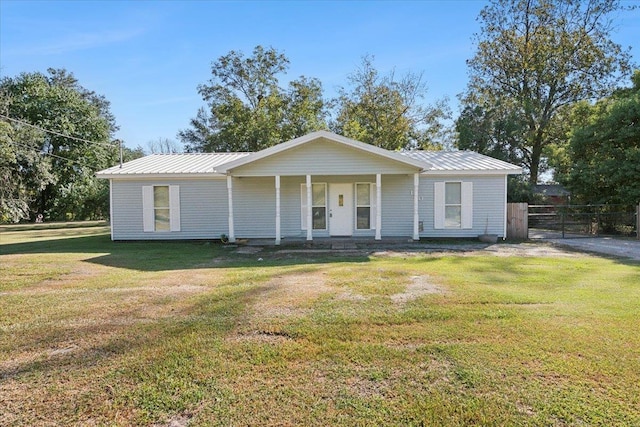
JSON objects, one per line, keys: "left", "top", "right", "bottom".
{"left": 178, "top": 46, "right": 326, "bottom": 152}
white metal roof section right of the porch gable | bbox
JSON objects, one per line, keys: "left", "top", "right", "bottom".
{"left": 400, "top": 150, "right": 522, "bottom": 175}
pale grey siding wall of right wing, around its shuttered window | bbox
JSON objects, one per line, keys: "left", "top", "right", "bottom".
{"left": 418, "top": 175, "right": 506, "bottom": 237}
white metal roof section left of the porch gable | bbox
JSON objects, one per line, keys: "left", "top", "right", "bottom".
{"left": 96, "top": 153, "right": 250, "bottom": 178}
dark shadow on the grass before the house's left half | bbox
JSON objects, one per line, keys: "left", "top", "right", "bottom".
{"left": 0, "top": 229, "right": 369, "bottom": 271}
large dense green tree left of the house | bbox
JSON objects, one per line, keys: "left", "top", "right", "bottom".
{"left": 0, "top": 69, "right": 117, "bottom": 220}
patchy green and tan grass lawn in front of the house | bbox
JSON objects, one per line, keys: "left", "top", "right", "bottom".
{"left": 0, "top": 227, "right": 640, "bottom": 426}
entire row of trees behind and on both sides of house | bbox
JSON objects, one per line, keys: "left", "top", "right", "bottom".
{"left": 0, "top": 0, "right": 640, "bottom": 222}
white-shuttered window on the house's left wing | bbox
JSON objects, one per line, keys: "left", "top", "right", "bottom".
{"left": 142, "top": 185, "right": 180, "bottom": 232}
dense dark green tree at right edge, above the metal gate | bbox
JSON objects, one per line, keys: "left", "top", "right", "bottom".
{"left": 564, "top": 70, "right": 640, "bottom": 205}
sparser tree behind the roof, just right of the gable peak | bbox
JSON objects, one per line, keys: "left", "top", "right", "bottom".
{"left": 332, "top": 56, "right": 448, "bottom": 150}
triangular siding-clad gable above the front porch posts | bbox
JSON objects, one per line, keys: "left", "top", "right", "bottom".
{"left": 232, "top": 140, "right": 418, "bottom": 176}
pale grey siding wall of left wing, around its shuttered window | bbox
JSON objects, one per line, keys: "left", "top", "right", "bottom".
{"left": 111, "top": 179, "right": 229, "bottom": 240}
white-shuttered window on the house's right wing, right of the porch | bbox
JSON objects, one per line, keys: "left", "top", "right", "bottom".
{"left": 433, "top": 181, "right": 473, "bottom": 229}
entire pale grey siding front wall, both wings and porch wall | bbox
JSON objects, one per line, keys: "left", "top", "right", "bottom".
{"left": 111, "top": 174, "right": 506, "bottom": 240}
